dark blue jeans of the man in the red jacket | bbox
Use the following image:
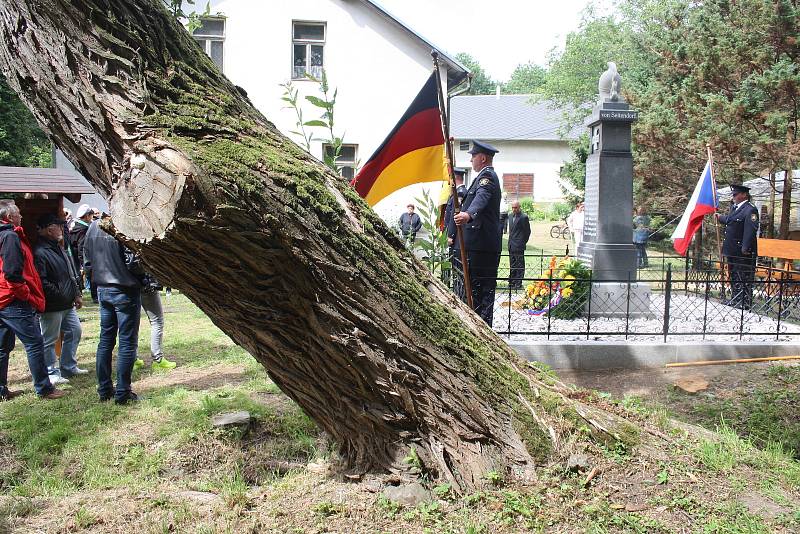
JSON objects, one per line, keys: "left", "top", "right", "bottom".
{"left": 0, "top": 300, "right": 53, "bottom": 396}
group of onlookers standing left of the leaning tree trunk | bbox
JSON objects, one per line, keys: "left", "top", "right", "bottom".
{"left": 0, "top": 200, "right": 176, "bottom": 404}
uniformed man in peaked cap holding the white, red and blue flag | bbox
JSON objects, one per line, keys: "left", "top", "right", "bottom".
{"left": 717, "top": 185, "right": 759, "bottom": 310}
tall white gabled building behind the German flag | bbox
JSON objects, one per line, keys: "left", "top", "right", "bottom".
{"left": 186, "top": 0, "right": 468, "bottom": 222}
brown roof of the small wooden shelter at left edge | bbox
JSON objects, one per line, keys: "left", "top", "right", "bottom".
{"left": 0, "top": 167, "right": 96, "bottom": 194}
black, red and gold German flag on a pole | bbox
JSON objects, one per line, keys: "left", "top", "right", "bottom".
{"left": 351, "top": 73, "right": 448, "bottom": 206}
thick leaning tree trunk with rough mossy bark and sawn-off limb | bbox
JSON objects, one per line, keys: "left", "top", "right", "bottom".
{"left": 0, "top": 0, "right": 639, "bottom": 489}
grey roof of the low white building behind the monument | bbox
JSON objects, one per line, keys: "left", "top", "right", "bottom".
{"left": 450, "top": 95, "right": 583, "bottom": 141}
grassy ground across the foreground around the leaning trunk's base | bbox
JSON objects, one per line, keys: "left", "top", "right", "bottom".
{"left": 0, "top": 295, "right": 800, "bottom": 533}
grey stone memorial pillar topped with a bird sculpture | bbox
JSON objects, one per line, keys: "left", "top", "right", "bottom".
{"left": 577, "top": 63, "right": 650, "bottom": 317}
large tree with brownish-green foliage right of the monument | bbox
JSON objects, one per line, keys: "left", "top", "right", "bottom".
{"left": 625, "top": 0, "right": 800, "bottom": 233}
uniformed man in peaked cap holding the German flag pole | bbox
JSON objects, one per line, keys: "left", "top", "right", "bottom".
{"left": 453, "top": 141, "right": 502, "bottom": 326}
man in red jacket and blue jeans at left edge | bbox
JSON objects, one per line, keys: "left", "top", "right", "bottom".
{"left": 0, "top": 200, "right": 64, "bottom": 401}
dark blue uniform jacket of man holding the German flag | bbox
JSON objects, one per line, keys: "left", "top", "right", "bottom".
{"left": 461, "top": 167, "right": 496, "bottom": 252}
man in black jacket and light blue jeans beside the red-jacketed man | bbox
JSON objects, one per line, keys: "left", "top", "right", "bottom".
{"left": 33, "top": 213, "right": 89, "bottom": 385}
